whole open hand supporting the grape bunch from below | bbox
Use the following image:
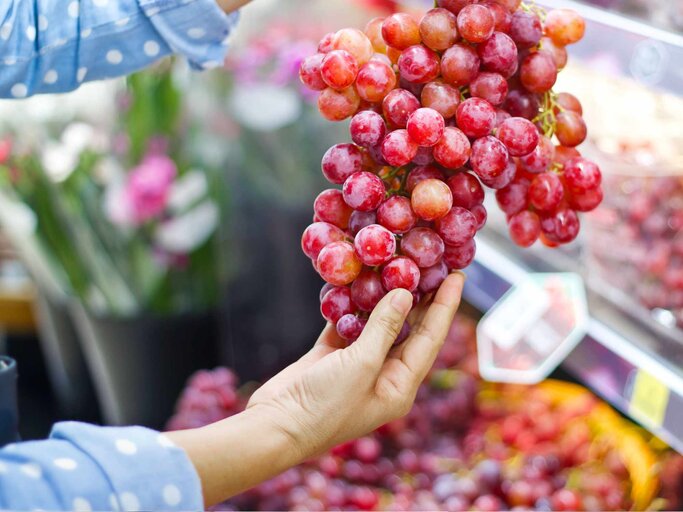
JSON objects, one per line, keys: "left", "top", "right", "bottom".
{"left": 247, "top": 273, "right": 464, "bottom": 460}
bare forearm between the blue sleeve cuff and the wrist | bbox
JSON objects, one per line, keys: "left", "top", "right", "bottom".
{"left": 167, "top": 407, "right": 304, "bottom": 507}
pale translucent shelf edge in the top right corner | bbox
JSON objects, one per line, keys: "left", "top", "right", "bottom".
{"left": 538, "top": 0, "right": 683, "bottom": 95}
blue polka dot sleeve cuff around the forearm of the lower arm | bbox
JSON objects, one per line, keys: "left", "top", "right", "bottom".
{"left": 0, "top": 422, "right": 204, "bottom": 512}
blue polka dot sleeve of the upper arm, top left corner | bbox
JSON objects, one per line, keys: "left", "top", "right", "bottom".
{"left": 0, "top": 0, "right": 238, "bottom": 98}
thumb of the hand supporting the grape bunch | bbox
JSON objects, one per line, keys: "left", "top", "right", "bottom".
{"left": 349, "top": 289, "right": 413, "bottom": 370}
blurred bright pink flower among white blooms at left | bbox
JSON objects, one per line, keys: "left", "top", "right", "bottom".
{"left": 124, "top": 154, "right": 177, "bottom": 223}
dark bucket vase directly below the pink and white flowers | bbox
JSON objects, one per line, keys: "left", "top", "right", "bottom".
{"left": 72, "top": 305, "right": 218, "bottom": 429}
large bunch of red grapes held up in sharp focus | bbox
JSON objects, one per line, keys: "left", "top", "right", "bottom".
{"left": 300, "top": 0, "right": 602, "bottom": 341}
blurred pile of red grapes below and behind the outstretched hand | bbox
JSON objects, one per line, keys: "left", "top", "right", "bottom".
{"left": 168, "top": 317, "right": 683, "bottom": 511}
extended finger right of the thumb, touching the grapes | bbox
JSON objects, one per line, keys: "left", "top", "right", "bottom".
{"left": 401, "top": 272, "right": 465, "bottom": 384}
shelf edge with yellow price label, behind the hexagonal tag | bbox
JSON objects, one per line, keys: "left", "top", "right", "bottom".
{"left": 464, "top": 234, "right": 683, "bottom": 453}
